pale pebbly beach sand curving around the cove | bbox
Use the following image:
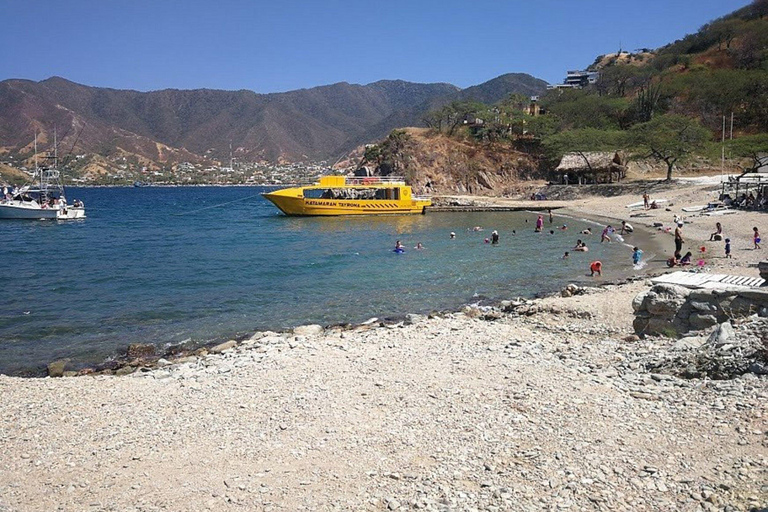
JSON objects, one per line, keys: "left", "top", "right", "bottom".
{"left": 0, "top": 181, "right": 768, "bottom": 511}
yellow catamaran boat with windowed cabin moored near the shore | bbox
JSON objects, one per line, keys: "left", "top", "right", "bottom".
{"left": 262, "top": 176, "right": 432, "bottom": 215}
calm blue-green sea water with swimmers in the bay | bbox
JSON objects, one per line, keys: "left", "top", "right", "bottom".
{"left": 0, "top": 187, "right": 631, "bottom": 374}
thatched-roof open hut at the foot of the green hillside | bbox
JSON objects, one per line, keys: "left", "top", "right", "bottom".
{"left": 554, "top": 151, "right": 627, "bottom": 185}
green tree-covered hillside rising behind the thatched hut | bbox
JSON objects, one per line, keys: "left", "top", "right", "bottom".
{"left": 414, "top": 0, "right": 768, "bottom": 178}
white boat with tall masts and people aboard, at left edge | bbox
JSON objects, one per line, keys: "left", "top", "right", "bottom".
{"left": 0, "top": 134, "right": 85, "bottom": 220}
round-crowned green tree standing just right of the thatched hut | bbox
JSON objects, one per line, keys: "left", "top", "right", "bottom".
{"left": 629, "top": 114, "right": 712, "bottom": 181}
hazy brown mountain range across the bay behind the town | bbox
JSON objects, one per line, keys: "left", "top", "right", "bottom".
{"left": 0, "top": 74, "right": 547, "bottom": 168}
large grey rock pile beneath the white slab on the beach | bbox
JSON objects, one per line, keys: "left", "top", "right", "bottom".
{"left": 632, "top": 284, "right": 768, "bottom": 336}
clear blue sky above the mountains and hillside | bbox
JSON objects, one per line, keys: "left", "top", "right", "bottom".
{"left": 0, "top": 0, "right": 749, "bottom": 93}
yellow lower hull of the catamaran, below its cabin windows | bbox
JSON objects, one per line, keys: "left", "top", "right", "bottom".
{"left": 263, "top": 192, "right": 432, "bottom": 216}
